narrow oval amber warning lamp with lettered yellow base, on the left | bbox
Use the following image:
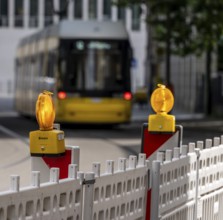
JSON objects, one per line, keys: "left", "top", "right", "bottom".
{"left": 29, "top": 90, "right": 65, "bottom": 156}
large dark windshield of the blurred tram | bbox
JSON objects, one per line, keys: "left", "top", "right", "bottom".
{"left": 59, "top": 40, "right": 130, "bottom": 95}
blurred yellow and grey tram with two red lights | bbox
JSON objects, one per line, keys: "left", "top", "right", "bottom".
{"left": 15, "top": 20, "right": 132, "bottom": 124}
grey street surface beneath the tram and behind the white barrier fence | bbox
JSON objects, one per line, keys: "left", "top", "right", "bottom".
{"left": 0, "top": 100, "right": 223, "bottom": 191}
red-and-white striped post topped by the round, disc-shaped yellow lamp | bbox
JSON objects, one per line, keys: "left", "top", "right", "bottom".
{"left": 141, "top": 84, "right": 183, "bottom": 220}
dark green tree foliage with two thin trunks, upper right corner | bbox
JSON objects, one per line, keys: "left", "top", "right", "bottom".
{"left": 116, "top": 0, "right": 223, "bottom": 114}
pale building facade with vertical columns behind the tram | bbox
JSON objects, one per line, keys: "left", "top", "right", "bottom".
{"left": 0, "top": 0, "right": 146, "bottom": 97}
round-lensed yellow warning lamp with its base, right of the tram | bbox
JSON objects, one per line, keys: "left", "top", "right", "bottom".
{"left": 148, "top": 84, "right": 175, "bottom": 133}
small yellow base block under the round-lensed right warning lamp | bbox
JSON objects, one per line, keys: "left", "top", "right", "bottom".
{"left": 148, "top": 114, "right": 175, "bottom": 133}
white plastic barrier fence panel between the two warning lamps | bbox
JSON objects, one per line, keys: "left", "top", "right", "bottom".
{"left": 93, "top": 154, "right": 148, "bottom": 220}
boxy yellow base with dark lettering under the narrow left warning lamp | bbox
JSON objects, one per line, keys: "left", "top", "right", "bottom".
{"left": 29, "top": 130, "right": 65, "bottom": 156}
